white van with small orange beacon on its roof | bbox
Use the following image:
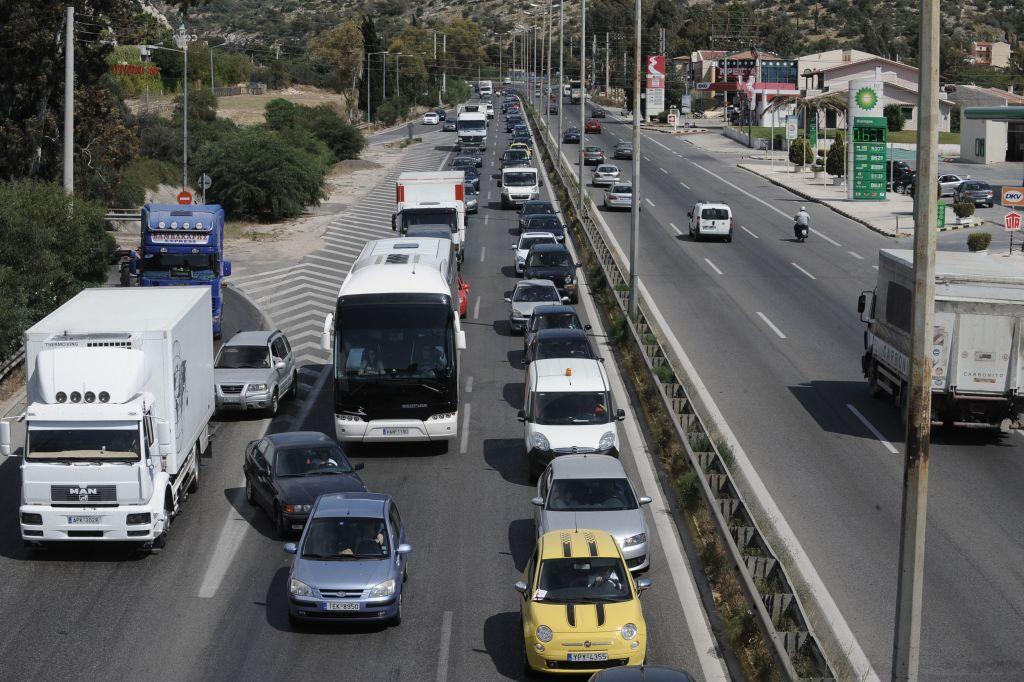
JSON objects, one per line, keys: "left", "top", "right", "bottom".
{"left": 518, "top": 358, "right": 626, "bottom": 479}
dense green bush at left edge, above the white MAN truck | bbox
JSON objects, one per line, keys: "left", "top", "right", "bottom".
{"left": 0, "top": 180, "right": 114, "bottom": 358}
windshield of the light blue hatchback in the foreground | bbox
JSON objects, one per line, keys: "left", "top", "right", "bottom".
{"left": 302, "top": 516, "right": 391, "bottom": 561}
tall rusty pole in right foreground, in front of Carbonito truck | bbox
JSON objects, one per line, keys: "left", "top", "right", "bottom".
{"left": 892, "top": 0, "right": 939, "bottom": 680}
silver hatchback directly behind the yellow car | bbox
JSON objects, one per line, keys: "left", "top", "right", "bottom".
{"left": 530, "top": 455, "right": 650, "bottom": 571}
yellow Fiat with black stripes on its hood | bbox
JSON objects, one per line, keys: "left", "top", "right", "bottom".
{"left": 515, "top": 530, "right": 650, "bottom": 675}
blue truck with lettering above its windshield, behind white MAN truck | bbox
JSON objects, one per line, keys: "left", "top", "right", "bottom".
{"left": 130, "top": 204, "right": 231, "bottom": 338}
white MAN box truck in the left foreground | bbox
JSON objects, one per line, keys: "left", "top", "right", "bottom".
{"left": 0, "top": 287, "right": 214, "bottom": 551}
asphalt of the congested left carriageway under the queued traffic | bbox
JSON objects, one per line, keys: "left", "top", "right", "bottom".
{"left": 0, "top": 110, "right": 721, "bottom": 682}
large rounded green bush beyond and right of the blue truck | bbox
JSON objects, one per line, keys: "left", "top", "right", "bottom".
{"left": 195, "top": 126, "right": 328, "bottom": 220}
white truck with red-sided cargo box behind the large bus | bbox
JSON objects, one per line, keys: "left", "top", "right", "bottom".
{"left": 391, "top": 171, "right": 466, "bottom": 263}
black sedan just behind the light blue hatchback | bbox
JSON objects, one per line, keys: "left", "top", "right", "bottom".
{"left": 242, "top": 431, "right": 367, "bottom": 538}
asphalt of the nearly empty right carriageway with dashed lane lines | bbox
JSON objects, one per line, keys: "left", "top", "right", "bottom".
{"left": 551, "top": 96, "right": 1024, "bottom": 679}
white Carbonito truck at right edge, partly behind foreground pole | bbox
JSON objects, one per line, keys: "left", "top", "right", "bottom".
{"left": 857, "top": 249, "right": 1024, "bottom": 430}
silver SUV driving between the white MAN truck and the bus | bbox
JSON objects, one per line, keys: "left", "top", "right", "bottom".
{"left": 213, "top": 331, "right": 299, "bottom": 417}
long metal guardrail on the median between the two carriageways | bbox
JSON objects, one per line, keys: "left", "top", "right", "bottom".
{"left": 526, "top": 98, "right": 836, "bottom": 680}
